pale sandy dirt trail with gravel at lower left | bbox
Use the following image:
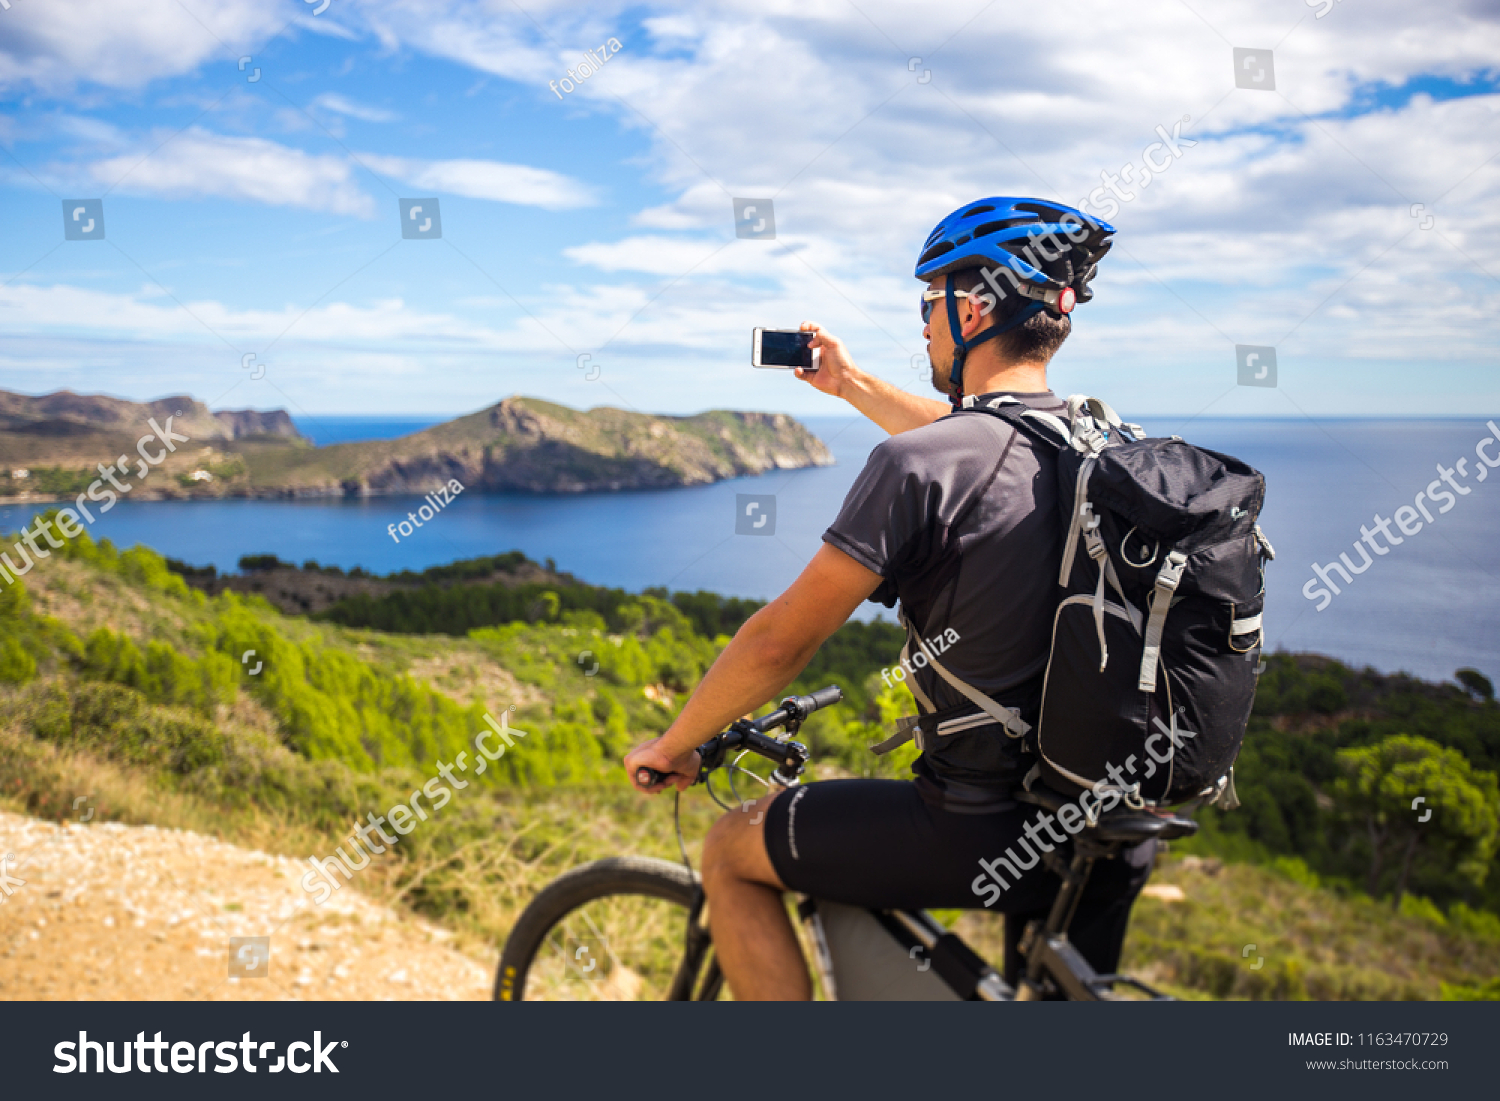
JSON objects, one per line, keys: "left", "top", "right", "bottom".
{"left": 0, "top": 813, "right": 495, "bottom": 1001}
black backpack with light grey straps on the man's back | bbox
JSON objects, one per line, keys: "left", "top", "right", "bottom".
{"left": 894, "top": 396, "right": 1275, "bottom": 809}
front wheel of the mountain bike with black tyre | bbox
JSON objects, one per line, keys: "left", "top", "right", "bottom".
{"left": 495, "top": 857, "right": 720, "bottom": 1002}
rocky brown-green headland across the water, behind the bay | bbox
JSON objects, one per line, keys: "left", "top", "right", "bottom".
{"left": 0, "top": 390, "right": 833, "bottom": 503}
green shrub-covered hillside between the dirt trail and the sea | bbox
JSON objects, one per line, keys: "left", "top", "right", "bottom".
{"left": 0, "top": 516, "right": 1500, "bottom": 998}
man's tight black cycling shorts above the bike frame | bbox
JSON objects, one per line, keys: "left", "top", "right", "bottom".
{"left": 765, "top": 780, "right": 1157, "bottom": 974}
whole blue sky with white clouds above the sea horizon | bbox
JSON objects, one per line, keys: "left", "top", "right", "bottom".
{"left": 0, "top": 0, "right": 1500, "bottom": 416}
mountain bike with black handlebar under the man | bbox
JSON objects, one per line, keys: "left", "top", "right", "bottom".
{"left": 495, "top": 686, "right": 1197, "bottom": 1002}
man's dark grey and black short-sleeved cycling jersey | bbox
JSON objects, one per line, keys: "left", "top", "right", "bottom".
{"left": 824, "top": 390, "right": 1067, "bottom": 809}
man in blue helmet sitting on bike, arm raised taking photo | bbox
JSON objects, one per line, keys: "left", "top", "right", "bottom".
{"left": 626, "top": 198, "right": 1155, "bottom": 1001}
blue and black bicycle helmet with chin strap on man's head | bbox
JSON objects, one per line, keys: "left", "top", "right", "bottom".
{"left": 917, "top": 197, "right": 1115, "bottom": 405}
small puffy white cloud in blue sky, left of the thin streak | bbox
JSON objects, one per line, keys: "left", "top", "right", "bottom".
{"left": 89, "top": 128, "right": 375, "bottom": 218}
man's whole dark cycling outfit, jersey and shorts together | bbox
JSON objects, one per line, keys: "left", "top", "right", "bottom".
{"left": 765, "top": 392, "right": 1155, "bottom": 974}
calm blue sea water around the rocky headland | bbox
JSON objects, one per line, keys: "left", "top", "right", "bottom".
{"left": 0, "top": 417, "right": 1500, "bottom": 678}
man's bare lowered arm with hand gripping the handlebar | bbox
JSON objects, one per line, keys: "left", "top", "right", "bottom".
{"left": 626, "top": 543, "right": 881, "bottom": 791}
